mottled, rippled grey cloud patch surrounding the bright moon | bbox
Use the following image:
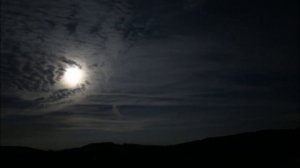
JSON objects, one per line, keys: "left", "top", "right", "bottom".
{"left": 1, "top": 0, "right": 136, "bottom": 114}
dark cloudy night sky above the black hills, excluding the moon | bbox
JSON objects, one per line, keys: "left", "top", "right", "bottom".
{"left": 1, "top": 0, "right": 300, "bottom": 149}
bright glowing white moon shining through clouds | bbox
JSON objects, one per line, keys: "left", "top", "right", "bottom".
{"left": 62, "top": 66, "right": 84, "bottom": 88}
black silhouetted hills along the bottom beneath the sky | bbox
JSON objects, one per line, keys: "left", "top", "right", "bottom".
{"left": 0, "top": 129, "right": 300, "bottom": 167}
